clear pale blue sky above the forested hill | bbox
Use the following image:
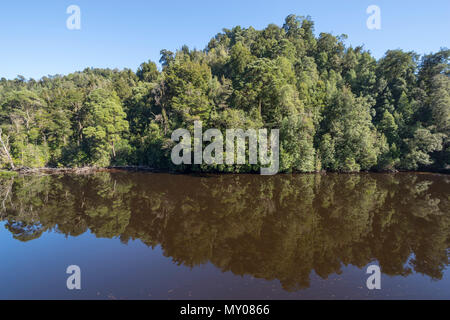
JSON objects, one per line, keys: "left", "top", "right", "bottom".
{"left": 0, "top": 0, "right": 450, "bottom": 79}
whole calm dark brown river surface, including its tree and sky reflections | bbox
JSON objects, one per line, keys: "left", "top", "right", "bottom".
{"left": 0, "top": 173, "right": 450, "bottom": 299}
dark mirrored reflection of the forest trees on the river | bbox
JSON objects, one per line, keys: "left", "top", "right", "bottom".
{"left": 0, "top": 172, "right": 450, "bottom": 291}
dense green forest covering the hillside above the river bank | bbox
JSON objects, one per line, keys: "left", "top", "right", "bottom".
{"left": 0, "top": 15, "right": 450, "bottom": 172}
